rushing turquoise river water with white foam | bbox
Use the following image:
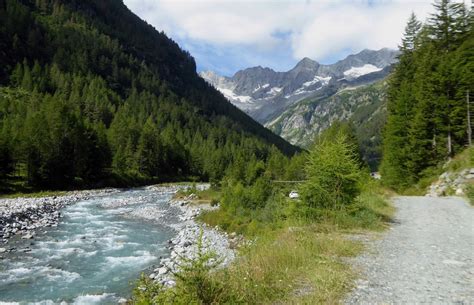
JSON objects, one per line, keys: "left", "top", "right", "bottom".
{"left": 0, "top": 189, "right": 178, "bottom": 304}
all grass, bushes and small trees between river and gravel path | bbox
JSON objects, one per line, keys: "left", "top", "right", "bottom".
{"left": 132, "top": 123, "right": 393, "bottom": 304}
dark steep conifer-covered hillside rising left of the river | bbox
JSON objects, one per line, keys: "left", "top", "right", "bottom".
{"left": 0, "top": 0, "right": 296, "bottom": 191}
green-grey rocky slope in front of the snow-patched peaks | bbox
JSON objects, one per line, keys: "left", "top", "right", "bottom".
{"left": 266, "top": 80, "right": 387, "bottom": 168}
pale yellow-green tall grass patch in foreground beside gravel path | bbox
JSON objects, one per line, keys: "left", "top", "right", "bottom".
{"left": 215, "top": 226, "right": 362, "bottom": 304}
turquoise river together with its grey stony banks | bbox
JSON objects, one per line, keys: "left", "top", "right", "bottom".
{"left": 0, "top": 184, "right": 238, "bottom": 304}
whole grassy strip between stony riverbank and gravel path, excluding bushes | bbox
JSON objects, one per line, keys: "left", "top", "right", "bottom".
{"left": 134, "top": 179, "right": 394, "bottom": 304}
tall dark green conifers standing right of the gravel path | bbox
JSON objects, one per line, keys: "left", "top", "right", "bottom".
{"left": 381, "top": 0, "right": 474, "bottom": 189}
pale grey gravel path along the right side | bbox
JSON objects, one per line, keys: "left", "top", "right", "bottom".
{"left": 346, "top": 197, "right": 474, "bottom": 304}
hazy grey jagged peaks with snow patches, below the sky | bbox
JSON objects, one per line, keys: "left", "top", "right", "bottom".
{"left": 200, "top": 49, "right": 398, "bottom": 124}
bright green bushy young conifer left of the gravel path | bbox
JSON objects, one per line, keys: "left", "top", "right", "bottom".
{"left": 300, "top": 133, "right": 361, "bottom": 213}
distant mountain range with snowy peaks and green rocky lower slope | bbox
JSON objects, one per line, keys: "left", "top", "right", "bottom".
{"left": 200, "top": 48, "right": 399, "bottom": 163}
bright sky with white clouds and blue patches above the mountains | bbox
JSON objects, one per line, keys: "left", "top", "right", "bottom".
{"left": 124, "top": 0, "right": 433, "bottom": 75}
